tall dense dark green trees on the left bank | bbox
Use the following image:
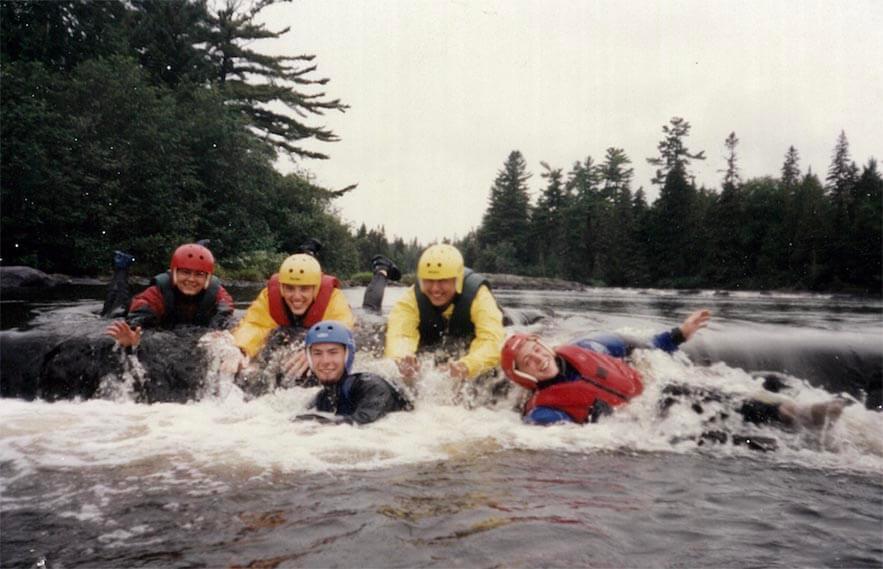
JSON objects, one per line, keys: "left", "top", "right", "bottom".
{"left": 0, "top": 0, "right": 386, "bottom": 277}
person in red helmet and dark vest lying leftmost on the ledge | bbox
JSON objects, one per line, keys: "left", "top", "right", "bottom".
{"left": 107, "top": 243, "right": 233, "bottom": 347}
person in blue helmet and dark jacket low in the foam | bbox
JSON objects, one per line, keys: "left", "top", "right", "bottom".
{"left": 295, "top": 320, "right": 413, "bottom": 425}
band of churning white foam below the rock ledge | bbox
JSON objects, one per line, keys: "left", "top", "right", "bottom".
{"left": 0, "top": 319, "right": 883, "bottom": 492}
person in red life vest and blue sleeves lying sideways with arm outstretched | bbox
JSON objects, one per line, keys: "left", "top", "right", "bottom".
{"left": 500, "top": 309, "right": 846, "bottom": 434}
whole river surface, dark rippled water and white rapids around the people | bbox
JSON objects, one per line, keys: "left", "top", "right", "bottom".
{"left": 0, "top": 287, "right": 883, "bottom": 568}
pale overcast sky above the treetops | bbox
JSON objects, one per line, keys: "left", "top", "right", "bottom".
{"left": 258, "top": 0, "right": 883, "bottom": 243}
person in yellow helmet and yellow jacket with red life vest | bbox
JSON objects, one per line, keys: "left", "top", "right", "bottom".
{"left": 233, "top": 253, "right": 355, "bottom": 377}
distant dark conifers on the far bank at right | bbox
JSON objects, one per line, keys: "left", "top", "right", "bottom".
{"left": 459, "top": 117, "right": 883, "bottom": 294}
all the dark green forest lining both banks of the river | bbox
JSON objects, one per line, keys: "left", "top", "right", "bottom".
{"left": 0, "top": 0, "right": 883, "bottom": 293}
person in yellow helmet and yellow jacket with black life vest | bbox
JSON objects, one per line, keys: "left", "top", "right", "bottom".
{"left": 385, "top": 244, "right": 505, "bottom": 380}
